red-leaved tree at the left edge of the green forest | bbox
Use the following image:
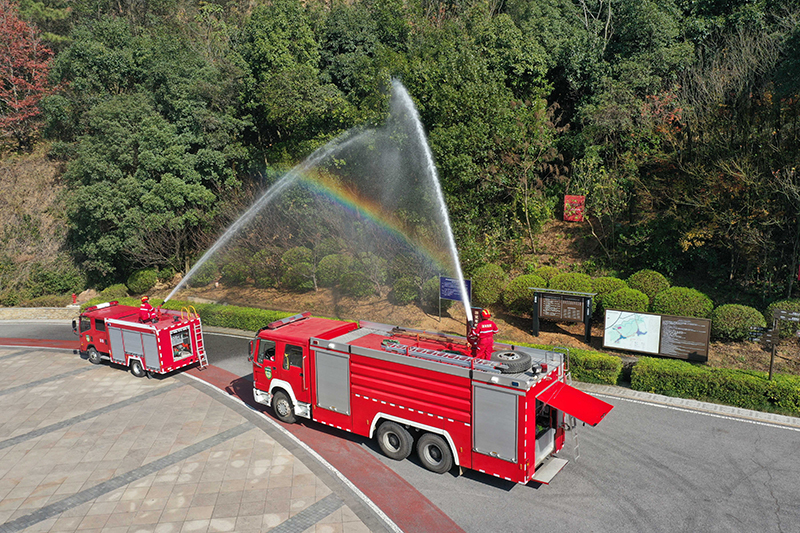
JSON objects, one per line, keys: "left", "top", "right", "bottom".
{"left": 0, "top": 0, "right": 53, "bottom": 151}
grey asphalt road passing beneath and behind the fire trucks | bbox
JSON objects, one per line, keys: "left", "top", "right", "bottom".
{"left": 0, "top": 324, "right": 800, "bottom": 533}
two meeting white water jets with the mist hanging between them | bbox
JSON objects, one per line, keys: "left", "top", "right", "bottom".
{"left": 165, "top": 80, "right": 472, "bottom": 322}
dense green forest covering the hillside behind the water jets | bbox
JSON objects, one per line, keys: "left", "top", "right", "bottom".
{"left": 0, "top": 0, "right": 800, "bottom": 306}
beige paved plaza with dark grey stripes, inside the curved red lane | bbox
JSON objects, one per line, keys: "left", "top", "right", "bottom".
{"left": 0, "top": 348, "right": 392, "bottom": 533}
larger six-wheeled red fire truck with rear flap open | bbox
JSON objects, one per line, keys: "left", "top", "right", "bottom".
{"left": 250, "top": 313, "right": 612, "bottom": 484}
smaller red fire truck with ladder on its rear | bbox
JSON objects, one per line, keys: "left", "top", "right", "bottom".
{"left": 72, "top": 302, "right": 208, "bottom": 377}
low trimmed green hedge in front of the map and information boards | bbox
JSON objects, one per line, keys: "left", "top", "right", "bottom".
{"left": 631, "top": 357, "right": 800, "bottom": 416}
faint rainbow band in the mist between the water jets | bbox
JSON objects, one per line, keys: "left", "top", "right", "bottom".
{"left": 300, "top": 167, "right": 455, "bottom": 274}
